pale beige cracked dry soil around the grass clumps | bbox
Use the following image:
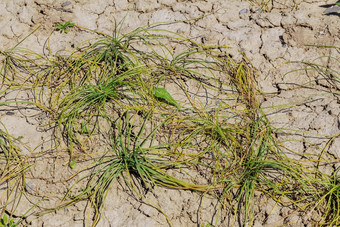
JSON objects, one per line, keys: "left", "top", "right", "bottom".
{"left": 0, "top": 0, "right": 340, "bottom": 226}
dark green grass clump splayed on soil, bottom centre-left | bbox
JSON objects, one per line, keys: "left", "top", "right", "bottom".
{"left": 58, "top": 112, "right": 211, "bottom": 225}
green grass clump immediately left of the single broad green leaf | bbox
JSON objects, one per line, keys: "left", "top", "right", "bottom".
{"left": 57, "top": 63, "right": 147, "bottom": 160}
